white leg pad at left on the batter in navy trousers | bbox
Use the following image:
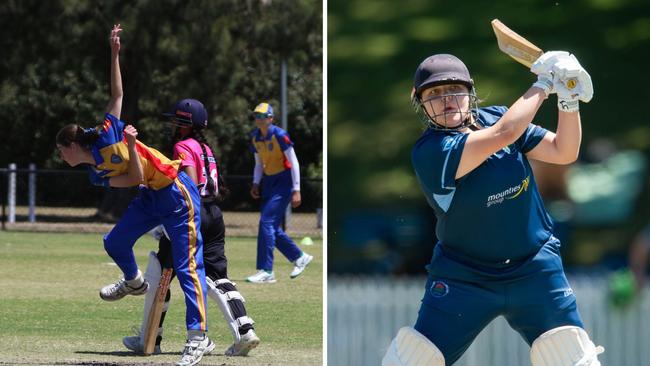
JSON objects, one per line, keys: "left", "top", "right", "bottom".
{"left": 381, "top": 327, "right": 445, "bottom": 366}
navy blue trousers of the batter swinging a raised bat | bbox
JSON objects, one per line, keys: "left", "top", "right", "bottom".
{"left": 415, "top": 238, "right": 583, "bottom": 365}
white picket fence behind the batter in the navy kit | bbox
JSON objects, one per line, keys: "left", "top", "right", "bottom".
{"left": 327, "top": 275, "right": 650, "bottom": 366}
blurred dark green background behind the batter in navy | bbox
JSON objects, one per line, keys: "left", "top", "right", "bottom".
{"left": 327, "top": 0, "right": 650, "bottom": 273}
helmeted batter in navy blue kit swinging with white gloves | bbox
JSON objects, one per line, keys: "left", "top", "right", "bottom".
{"left": 382, "top": 51, "right": 603, "bottom": 366}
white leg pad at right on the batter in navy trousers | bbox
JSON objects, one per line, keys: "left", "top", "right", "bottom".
{"left": 530, "top": 326, "right": 605, "bottom": 366}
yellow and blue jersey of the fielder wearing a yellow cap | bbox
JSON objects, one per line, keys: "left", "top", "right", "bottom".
{"left": 249, "top": 124, "right": 293, "bottom": 175}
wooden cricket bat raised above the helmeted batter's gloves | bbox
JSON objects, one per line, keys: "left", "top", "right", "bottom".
{"left": 492, "top": 19, "right": 577, "bottom": 89}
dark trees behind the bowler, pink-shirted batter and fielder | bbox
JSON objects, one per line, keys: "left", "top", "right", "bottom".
{"left": 0, "top": 0, "right": 323, "bottom": 178}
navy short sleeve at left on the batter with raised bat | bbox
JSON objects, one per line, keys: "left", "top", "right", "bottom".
{"left": 411, "top": 133, "right": 467, "bottom": 195}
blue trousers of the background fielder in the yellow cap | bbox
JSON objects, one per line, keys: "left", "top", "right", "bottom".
{"left": 257, "top": 170, "right": 302, "bottom": 271}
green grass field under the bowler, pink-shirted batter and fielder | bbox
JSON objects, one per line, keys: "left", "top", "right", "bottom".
{"left": 0, "top": 232, "right": 323, "bottom": 366}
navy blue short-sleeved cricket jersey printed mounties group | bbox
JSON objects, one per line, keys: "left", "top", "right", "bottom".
{"left": 411, "top": 106, "right": 552, "bottom": 269}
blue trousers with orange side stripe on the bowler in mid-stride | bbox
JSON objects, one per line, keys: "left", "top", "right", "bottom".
{"left": 104, "top": 172, "right": 207, "bottom": 331}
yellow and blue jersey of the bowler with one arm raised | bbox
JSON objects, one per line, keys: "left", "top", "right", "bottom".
{"left": 90, "top": 113, "right": 180, "bottom": 190}
